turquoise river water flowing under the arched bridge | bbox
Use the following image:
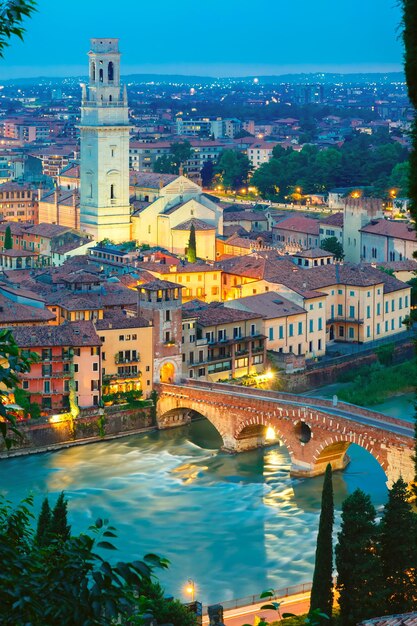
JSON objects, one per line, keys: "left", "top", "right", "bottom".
{"left": 0, "top": 394, "right": 413, "bottom": 603}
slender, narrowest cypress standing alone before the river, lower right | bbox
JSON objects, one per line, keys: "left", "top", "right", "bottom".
{"left": 310, "top": 463, "right": 334, "bottom": 623}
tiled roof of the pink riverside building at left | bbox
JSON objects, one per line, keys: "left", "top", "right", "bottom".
{"left": 10, "top": 322, "right": 101, "bottom": 349}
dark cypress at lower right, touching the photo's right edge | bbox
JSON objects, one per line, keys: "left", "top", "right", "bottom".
{"left": 380, "top": 478, "right": 417, "bottom": 615}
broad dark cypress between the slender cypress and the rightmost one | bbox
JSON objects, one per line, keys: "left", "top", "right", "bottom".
{"left": 336, "top": 489, "right": 381, "bottom": 626}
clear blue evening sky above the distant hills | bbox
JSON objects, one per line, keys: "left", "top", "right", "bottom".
{"left": 0, "top": 0, "right": 402, "bottom": 79}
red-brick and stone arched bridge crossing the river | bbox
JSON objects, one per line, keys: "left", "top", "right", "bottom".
{"left": 158, "top": 381, "right": 414, "bottom": 483}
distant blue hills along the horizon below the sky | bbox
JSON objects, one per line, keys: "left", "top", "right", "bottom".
{"left": 1, "top": 72, "right": 405, "bottom": 86}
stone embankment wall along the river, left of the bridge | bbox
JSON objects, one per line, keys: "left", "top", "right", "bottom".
{"left": 0, "top": 406, "right": 153, "bottom": 456}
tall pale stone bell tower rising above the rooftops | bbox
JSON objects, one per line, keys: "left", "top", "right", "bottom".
{"left": 79, "top": 39, "right": 131, "bottom": 243}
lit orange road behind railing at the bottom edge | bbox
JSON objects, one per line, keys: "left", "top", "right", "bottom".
{"left": 203, "top": 593, "right": 310, "bottom": 626}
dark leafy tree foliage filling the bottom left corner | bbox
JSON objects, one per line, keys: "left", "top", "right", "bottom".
{"left": 0, "top": 497, "right": 168, "bottom": 626}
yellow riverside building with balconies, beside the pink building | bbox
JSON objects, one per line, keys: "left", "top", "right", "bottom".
{"left": 96, "top": 313, "right": 153, "bottom": 397}
